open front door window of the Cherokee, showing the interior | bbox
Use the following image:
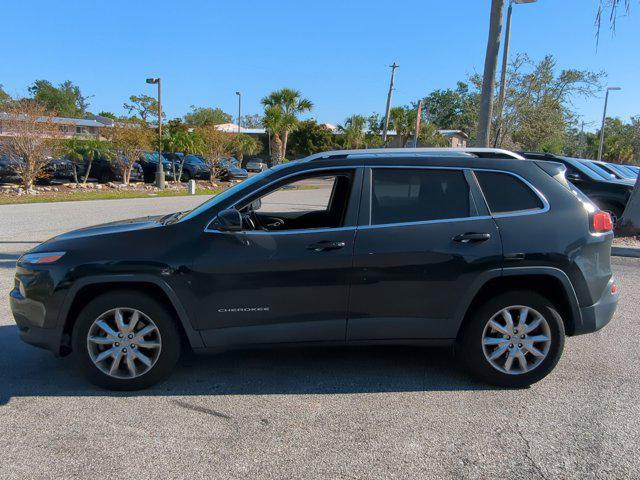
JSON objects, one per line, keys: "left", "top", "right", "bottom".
{"left": 239, "top": 171, "right": 353, "bottom": 231}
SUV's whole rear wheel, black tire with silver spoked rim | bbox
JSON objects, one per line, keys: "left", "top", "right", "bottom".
{"left": 456, "top": 290, "right": 565, "bottom": 388}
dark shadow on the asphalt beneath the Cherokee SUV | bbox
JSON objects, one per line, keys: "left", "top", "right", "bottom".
{"left": 0, "top": 326, "right": 493, "bottom": 405}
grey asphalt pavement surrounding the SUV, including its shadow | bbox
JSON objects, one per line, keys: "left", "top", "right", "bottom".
{"left": 0, "top": 198, "right": 640, "bottom": 479}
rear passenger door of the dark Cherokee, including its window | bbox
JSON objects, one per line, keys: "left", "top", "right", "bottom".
{"left": 347, "top": 167, "right": 502, "bottom": 341}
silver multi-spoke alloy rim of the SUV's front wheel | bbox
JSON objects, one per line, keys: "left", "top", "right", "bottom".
{"left": 87, "top": 307, "right": 162, "bottom": 379}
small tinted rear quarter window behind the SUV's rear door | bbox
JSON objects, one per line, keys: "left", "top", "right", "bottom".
{"left": 475, "top": 171, "right": 543, "bottom": 213}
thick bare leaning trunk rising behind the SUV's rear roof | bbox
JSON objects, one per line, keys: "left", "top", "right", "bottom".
{"left": 476, "top": 0, "right": 504, "bottom": 147}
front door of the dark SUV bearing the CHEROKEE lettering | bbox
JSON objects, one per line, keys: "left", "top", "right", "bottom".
{"left": 193, "top": 168, "right": 362, "bottom": 346}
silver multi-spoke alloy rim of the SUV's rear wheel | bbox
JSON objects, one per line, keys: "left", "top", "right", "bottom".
{"left": 482, "top": 305, "right": 551, "bottom": 375}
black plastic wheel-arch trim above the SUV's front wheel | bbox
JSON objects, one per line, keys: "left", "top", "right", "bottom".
{"left": 58, "top": 275, "right": 204, "bottom": 355}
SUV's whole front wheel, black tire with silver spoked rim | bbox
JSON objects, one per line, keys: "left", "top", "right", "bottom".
{"left": 72, "top": 291, "right": 180, "bottom": 390}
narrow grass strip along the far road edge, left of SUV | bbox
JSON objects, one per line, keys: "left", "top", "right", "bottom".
{"left": 0, "top": 187, "right": 223, "bottom": 205}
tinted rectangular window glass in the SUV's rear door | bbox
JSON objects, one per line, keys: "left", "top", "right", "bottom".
{"left": 371, "top": 168, "right": 475, "bottom": 225}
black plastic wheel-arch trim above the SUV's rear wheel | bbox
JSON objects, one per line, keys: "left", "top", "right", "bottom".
{"left": 456, "top": 267, "right": 582, "bottom": 338}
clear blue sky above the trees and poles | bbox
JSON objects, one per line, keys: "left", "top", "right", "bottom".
{"left": 0, "top": 0, "right": 640, "bottom": 129}
